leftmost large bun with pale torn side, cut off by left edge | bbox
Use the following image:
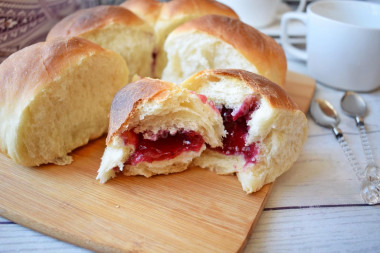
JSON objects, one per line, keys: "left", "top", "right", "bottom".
{"left": 0, "top": 38, "right": 128, "bottom": 166}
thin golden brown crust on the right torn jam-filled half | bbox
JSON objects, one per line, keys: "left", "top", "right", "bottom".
{"left": 184, "top": 69, "right": 299, "bottom": 111}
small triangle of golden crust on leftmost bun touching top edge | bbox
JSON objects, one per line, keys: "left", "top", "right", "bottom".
{"left": 120, "top": 0, "right": 165, "bottom": 26}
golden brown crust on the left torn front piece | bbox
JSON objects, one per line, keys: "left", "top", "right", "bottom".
{"left": 106, "top": 78, "right": 173, "bottom": 145}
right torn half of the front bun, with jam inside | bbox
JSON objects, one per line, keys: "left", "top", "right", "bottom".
{"left": 182, "top": 69, "right": 307, "bottom": 193}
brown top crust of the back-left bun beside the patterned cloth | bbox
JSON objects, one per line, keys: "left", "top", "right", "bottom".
{"left": 46, "top": 6, "right": 145, "bottom": 40}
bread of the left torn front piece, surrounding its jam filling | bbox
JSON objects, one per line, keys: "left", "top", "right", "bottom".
{"left": 97, "top": 78, "right": 224, "bottom": 183}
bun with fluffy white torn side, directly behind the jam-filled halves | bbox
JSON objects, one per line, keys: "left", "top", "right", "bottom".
{"left": 162, "top": 15, "right": 286, "bottom": 85}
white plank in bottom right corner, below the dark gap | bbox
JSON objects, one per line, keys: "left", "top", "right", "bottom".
{"left": 245, "top": 206, "right": 380, "bottom": 253}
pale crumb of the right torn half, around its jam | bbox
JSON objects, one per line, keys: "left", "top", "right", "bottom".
{"left": 183, "top": 71, "right": 307, "bottom": 193}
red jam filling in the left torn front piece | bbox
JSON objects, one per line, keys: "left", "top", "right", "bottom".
{"left": 121, "top": 131, "right": 204, "bottom": 165}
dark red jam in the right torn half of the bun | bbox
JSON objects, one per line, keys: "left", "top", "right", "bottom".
{"left": 212, "top": 96, "right": 258, "bottom": 163}
